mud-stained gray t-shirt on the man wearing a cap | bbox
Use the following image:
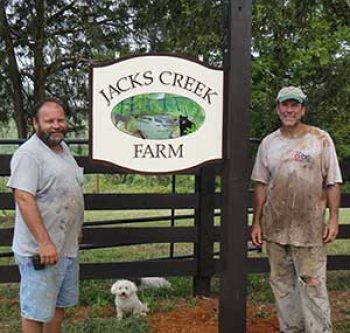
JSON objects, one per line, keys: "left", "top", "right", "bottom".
{"left": 252, "top": 126, "right": 342, "bottom": 246}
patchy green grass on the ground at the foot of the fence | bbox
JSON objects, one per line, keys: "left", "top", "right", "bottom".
{"left": 0, "top": 264, "right": 350, "bottom": 333}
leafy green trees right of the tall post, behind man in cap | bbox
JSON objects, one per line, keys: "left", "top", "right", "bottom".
{"left": 251, "top": 0, "right": 350, "bottom": 157}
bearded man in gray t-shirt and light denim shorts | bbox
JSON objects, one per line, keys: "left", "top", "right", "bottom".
{"left": 7, "top": 98, "right": 84, "bottom": 333}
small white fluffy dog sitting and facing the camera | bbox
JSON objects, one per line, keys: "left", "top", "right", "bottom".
{"left": 111, "top": 280, "right": 148, "bottom": 320}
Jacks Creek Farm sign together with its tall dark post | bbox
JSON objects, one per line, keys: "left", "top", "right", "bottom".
{"left": 90, "top": 0, "right": 252, "bottom": 333}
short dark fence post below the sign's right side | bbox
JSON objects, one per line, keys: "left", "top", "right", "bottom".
{"left": 193, "top": 165, "right": 215, "bottom": 296}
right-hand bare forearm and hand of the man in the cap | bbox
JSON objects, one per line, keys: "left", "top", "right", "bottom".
{"left": 323, "top": 183, "right": 340, "bottom": 243}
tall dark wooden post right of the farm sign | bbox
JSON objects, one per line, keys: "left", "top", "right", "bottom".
{"left": 219, "top": 0, "right": 251, "bottom": 333}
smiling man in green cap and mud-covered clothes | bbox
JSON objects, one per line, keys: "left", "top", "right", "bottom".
{"left": 251, "top": 86, "right": 342, "bottom": 333}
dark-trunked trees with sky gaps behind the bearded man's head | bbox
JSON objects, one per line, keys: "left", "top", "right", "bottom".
{"left": 0, "top": 0, "right": 129, "bottom": 137}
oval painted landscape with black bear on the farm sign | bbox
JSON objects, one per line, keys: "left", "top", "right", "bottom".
{"left": 111, "top": 93, "right": 205, "bottom": 140}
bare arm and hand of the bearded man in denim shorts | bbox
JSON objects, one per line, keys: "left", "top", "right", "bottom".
{"left": 14, "top": 189, "right": 58, "bottom": 265}
